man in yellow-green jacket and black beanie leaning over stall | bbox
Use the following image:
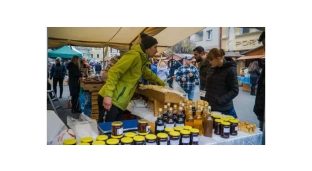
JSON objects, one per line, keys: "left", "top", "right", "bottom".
{"left": 98, "top": 33, "right": 166, "bottom": 122}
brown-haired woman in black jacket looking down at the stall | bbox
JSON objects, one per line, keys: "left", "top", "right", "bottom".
{"left": 205, "top": 48, "right": 239, "bottom": 118}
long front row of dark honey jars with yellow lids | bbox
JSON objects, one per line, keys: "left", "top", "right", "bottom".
{"left": 63, "top": 126, "right": 199, "bottom": 146}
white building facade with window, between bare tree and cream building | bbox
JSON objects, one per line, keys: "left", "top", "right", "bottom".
{"left": 190, "top": 26, "right": 221, "bottom": 51}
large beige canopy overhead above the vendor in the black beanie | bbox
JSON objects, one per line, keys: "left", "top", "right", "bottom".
{"left": 48, "top": 25, "right": 205, "bottom": 56}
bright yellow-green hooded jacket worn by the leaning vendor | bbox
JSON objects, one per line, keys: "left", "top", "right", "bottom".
{"left": 99, "top": 44, "right": 166, "bottom": 111}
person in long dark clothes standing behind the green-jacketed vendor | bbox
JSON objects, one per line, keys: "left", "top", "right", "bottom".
{"left": 67, "top": 56, "right": 82, "bottom": 113}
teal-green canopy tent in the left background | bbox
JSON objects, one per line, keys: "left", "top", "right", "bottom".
{"left": 48, "top": 46, "right": 82, "bottom": 59}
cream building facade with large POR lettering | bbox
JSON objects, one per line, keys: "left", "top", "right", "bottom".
{"left": 221, "top": 26, "right": 262, "bottom": 54}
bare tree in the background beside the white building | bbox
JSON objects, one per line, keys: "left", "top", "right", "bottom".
{"left": 166, "top": 38, "right": 196, "bottom": 55}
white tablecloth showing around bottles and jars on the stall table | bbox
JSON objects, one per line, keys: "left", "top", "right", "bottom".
{"left": 132, "top": 108, "right": 262, "bottom": 146}
